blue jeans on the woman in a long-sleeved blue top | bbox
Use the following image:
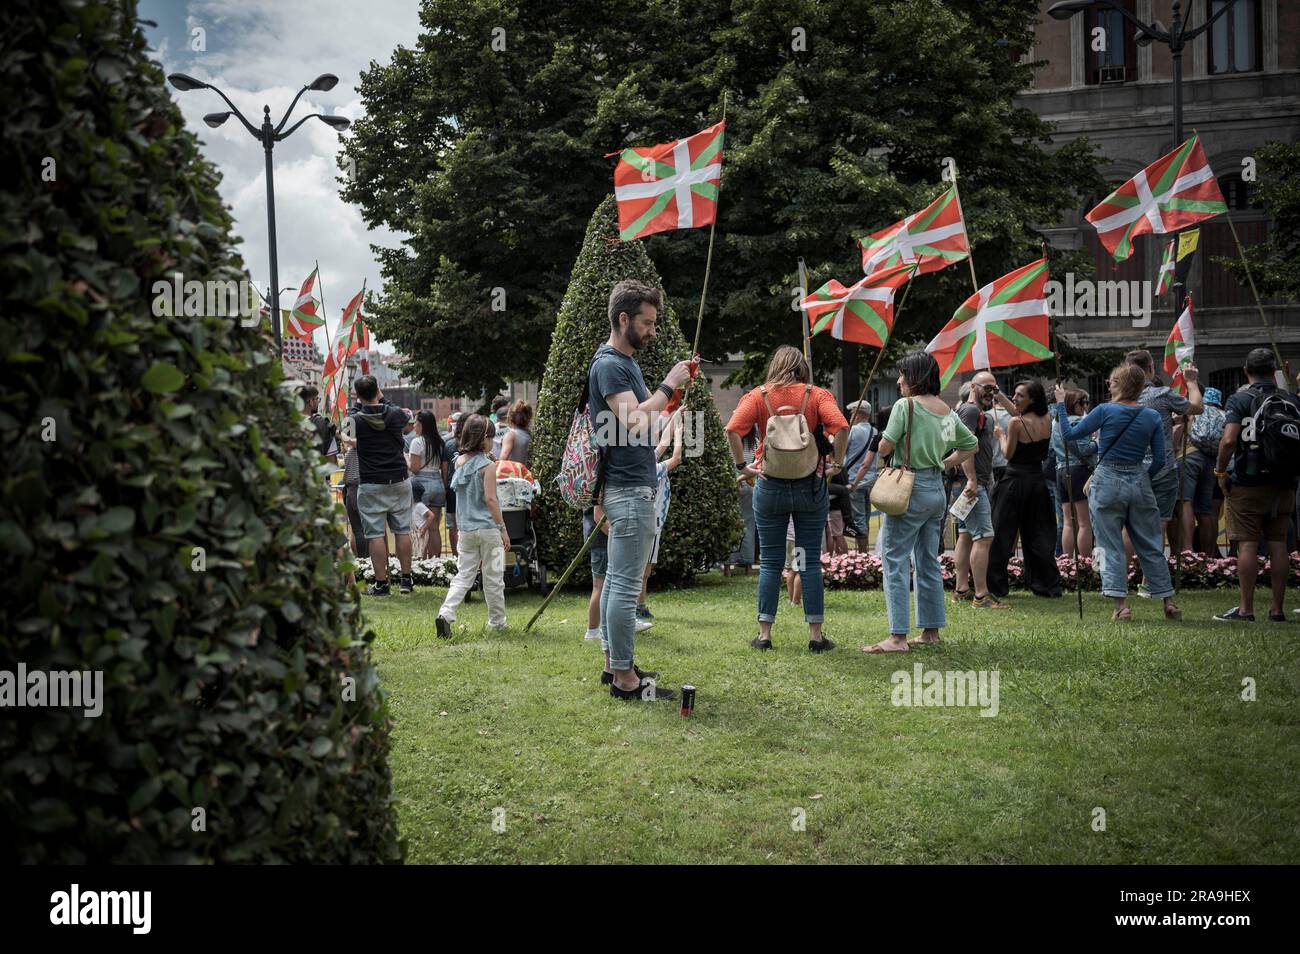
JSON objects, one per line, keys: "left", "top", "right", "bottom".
{"left": 1088, "top": 460, "right": 1174, "bottom": 599}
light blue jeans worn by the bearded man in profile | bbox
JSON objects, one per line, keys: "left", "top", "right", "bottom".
{"left": 601, "top": 487, "right": 654, "bottom": 669}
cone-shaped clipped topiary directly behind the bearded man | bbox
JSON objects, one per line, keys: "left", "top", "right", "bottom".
{"left": 533, "top": 195, "right": 744, "bottom": 584}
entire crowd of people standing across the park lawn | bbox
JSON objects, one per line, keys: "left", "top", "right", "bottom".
{"left": 303, "top": 279, "right": 1300, "bottom": 699}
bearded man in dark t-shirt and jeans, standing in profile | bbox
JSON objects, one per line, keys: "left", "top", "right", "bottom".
{"left": 586, "top": 278, "right": 690, "bottom": 701}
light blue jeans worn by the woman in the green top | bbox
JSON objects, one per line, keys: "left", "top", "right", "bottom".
{"left": 880, "top": 468, "right": 948, "bottom": 636}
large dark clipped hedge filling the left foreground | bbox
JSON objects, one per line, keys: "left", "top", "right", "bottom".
{"left": 0, "top": 0, "right": 402, "bottom": 863}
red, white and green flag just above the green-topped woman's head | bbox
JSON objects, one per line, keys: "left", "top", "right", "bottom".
{"left": 926, "top": 259, "right": 1053, "bottom": 386}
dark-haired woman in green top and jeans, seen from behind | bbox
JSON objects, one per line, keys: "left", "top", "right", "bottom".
{"left": 862, "top": 351, "right": 979, "bottom": 652}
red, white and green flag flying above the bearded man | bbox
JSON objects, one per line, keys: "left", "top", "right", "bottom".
{"left": 614, "top": 121, "right": 727, "bottom": 242}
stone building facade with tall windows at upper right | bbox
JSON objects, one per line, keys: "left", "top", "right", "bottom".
{"left": 1022, "top": 0, "right": 1300, "bottom": 399}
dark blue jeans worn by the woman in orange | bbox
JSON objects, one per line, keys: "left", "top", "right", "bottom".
{"left": 759, "top": 474, "right": 831, "bottom": 623}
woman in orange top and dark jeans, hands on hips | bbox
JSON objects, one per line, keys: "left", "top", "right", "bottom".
{"left": 727, "top": 344, "right": 849, "bottom": 652}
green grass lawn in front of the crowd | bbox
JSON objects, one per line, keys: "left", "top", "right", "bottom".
{"left": 363, "top": 573, "right": 1300, "bottom": 864}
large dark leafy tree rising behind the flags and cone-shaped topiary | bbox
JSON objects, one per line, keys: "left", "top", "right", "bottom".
{"left": 345, "top": 0, "right": 1101, "bottom": 393}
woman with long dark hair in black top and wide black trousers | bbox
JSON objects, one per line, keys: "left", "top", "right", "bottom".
{"left": 988, "top": 378, "right": 1061, "bottom": 600}
